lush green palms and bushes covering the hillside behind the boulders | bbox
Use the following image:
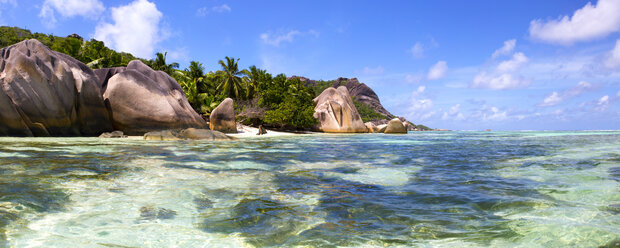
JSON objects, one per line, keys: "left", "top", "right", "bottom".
{"left": 0, "top": 27, "right": 428, "bottom": 130}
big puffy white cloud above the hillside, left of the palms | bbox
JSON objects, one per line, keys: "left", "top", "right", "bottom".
{"left": 95, "top": 0, "right": 163, "bottom": 58}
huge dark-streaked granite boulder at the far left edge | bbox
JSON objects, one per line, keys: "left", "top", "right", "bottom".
{"left": 0, "top": 39, "right": 112, "bottom": 136}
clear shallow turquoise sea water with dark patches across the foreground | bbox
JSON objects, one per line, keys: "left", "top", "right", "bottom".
{"left": 0, "top": 132, "right": 620, "bottom": 247}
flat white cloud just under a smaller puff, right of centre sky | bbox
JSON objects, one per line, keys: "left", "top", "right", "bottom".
{"left": 471, "top": 72, "right": 531, "bottom": 90}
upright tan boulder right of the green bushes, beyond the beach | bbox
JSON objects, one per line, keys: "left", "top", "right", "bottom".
{"left": 314, "top": 86, "right": 367, "bottom": 133}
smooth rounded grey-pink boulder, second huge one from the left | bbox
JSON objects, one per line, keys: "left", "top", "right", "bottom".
{"left": 97, "top": 60, "right": 206, "bottom": 135}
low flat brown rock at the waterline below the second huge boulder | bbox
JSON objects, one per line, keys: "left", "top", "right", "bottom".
{"left": 144, "top": 128, "right": 236, "bottom": 140}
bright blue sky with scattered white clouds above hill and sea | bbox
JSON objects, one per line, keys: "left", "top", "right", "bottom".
{"left": 0, "top": 0, "right": 620, "bottom": 130}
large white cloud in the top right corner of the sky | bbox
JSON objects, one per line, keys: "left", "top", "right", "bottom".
{"left": 529, "top": 0, "right": 620, "bottom": 45}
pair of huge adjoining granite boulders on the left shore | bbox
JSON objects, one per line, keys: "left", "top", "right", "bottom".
{"left": 0, "top": 39, "right": 206, "bottom": 136}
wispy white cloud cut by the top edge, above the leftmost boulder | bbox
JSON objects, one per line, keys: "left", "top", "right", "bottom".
{"left": 38, "top": 0, "right": 105, "bottom": 27}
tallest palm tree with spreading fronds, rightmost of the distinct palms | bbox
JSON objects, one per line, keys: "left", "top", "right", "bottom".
{"left": 217, "top": 56, "right": 244, "bottom": 99}
